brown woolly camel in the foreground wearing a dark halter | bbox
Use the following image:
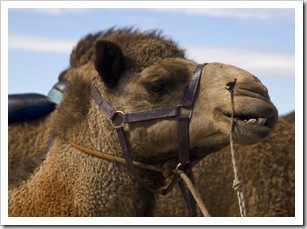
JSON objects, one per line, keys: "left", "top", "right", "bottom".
{"left": 8, "top": 29, "right": 278, "bottom": 216}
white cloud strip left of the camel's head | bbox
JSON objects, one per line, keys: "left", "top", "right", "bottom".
{"left": 8, "top": 34, "right": 77, "bottom": 54}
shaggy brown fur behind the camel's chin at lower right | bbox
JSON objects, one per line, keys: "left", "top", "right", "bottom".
{"left": 154, "top": 118, "right": 295, "bottom": 217}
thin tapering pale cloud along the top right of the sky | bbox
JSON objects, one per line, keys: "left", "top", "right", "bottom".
{"left": 154, "top": 8, "right": 295, "bottom": 22}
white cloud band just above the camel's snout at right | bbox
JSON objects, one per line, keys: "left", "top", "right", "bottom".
{"left": 185, "top": 45, "right": 295, "bottom": 78}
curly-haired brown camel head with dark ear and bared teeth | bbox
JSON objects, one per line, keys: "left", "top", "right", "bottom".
{"left": 58, "top": 30, "right": 278, "bottom": 164}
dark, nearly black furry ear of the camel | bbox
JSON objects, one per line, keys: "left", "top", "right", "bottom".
{"left": 94, "top": 40, "right": 124, "bottom": 87}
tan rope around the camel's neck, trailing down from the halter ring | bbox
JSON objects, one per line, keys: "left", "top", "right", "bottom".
{"left": 66, "top": 139, "right": 210, "bottom": 217}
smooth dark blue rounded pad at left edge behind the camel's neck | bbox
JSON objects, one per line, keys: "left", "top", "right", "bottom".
{"left": 8, "top": 93, "right": 55, "bottom": 123}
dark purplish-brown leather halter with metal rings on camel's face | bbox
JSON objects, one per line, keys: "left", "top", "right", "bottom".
{"left": 91, "top": 64, "right": 206, "bottom": 215}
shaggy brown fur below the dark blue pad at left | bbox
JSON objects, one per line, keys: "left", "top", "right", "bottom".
{"left": 8, "top": 111, "right": 56, "bottom": 189}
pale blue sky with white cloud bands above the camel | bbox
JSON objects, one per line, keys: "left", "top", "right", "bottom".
{"left": 4, "top": 3, "right": 295, "bottom": 114}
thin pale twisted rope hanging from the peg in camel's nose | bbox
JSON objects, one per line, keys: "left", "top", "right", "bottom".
{"left": 226, "top": 79, "right": 246, "bottom": 217}
